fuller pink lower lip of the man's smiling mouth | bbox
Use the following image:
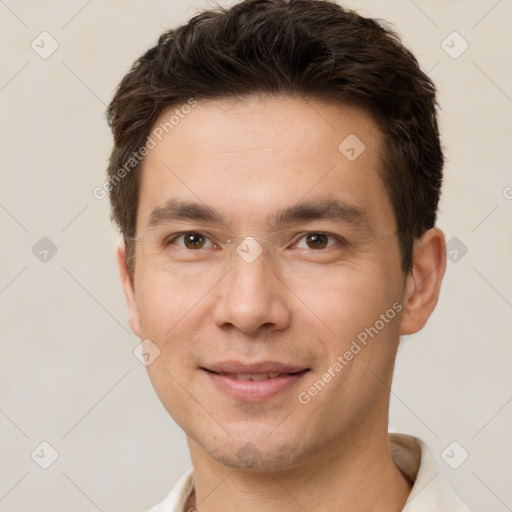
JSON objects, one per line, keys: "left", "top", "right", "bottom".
{"left": 203, "top": 370, "right": 307, "bottom": 402}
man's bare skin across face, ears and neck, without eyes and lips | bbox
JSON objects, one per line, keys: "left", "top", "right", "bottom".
{"left": 118, "top": 96, "right": 446, "bottom": 512}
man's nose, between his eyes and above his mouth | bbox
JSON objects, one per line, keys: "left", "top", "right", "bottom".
{"left": 214, "top": 241, "right": 291, "bottom": 333}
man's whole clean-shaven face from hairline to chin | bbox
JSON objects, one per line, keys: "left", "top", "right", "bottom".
{"left": 120, "top": 96, "right": 424, "bottom": 469}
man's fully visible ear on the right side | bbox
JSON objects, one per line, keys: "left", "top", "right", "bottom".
{"left": 400, "top": 228, "right": 446, "bottom": 335}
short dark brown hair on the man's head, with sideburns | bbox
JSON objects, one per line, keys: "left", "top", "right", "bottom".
{"left": 107, "top": 0, "right": 443, "bottom": 275}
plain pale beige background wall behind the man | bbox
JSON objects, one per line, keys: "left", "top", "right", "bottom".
{"left": 0, "top": 0, "right": 512, "bottom": 512}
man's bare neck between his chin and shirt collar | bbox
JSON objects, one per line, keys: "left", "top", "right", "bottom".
{"left": 185, "top": 425, "right": 411, "bottom": 512}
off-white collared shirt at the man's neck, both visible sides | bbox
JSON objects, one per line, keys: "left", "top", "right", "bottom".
{"left": 148, "top": 434, "right": 469, "bottom": 512}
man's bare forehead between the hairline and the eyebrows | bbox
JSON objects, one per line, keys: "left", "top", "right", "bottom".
{"left": 137, "top": 96, "right": 394, "bottom": 231}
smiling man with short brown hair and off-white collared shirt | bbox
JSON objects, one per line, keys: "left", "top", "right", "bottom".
{"left": 108, "top": 0, "right": 467, "bottom": 512}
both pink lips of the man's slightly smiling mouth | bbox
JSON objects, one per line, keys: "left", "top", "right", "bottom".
{"left": 200, "top": 361, "right": 309, "bottom": 402}
